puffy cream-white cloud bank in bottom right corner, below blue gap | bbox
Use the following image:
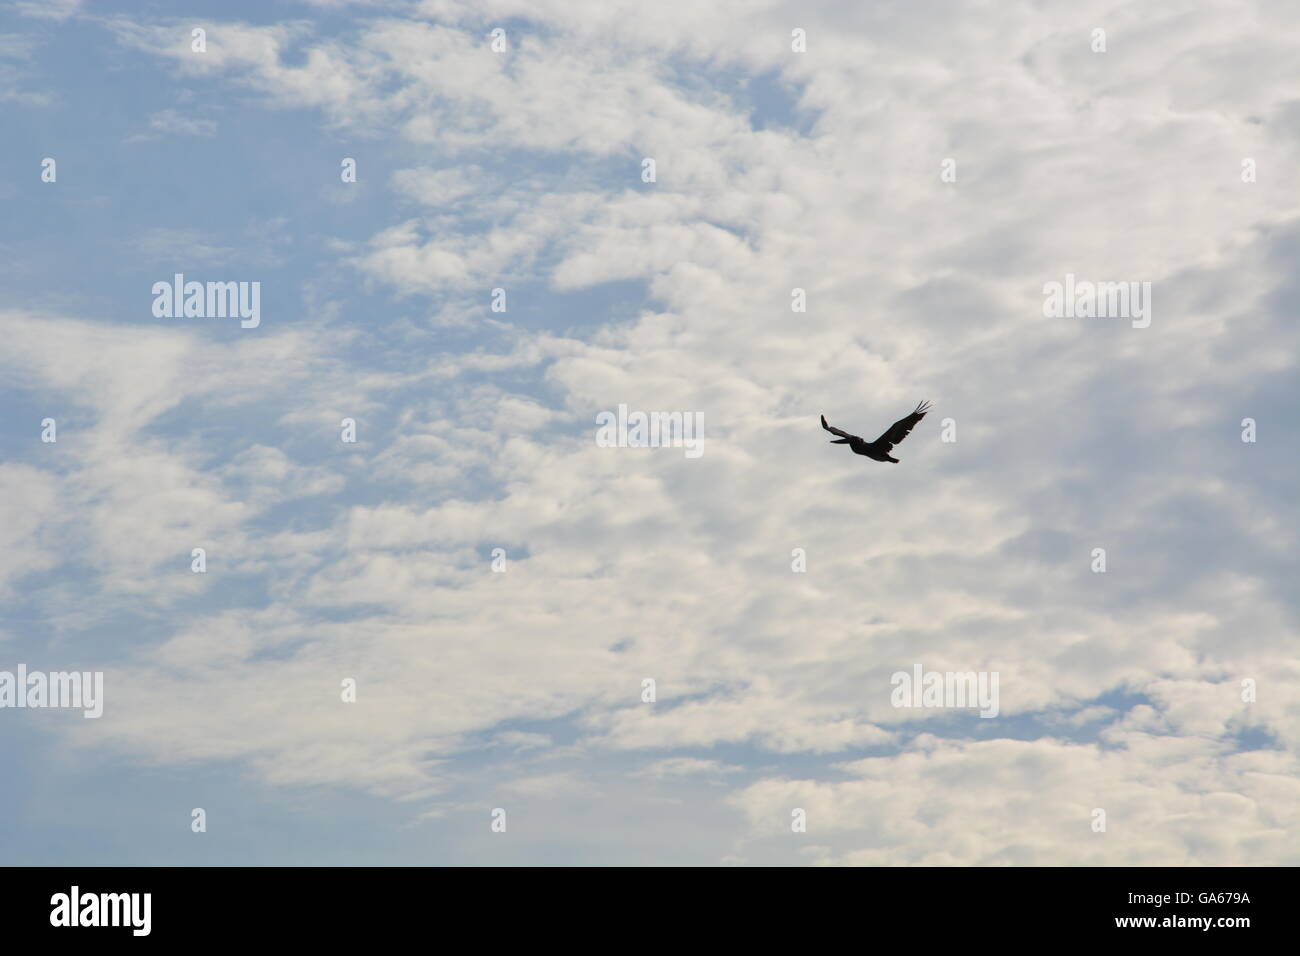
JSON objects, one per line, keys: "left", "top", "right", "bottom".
{"left": 735, "top": 735, "right": 1300, "bottom": 866}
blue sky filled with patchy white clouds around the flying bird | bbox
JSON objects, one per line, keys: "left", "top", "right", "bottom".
{"left": 0, "top": 0, "right": 1300, "bottom": 866}
